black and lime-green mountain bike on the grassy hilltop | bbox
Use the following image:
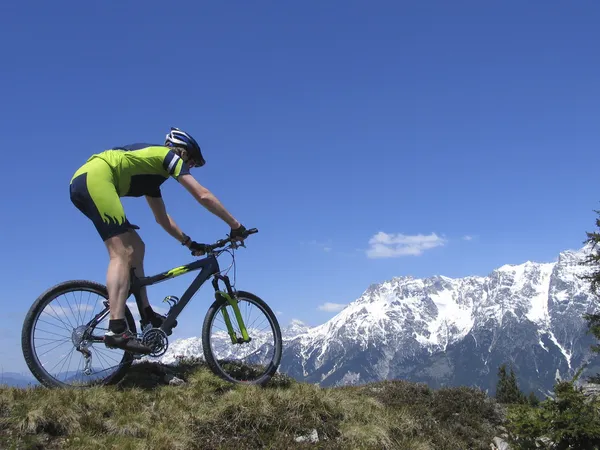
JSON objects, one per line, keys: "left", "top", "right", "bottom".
{"left": 21, "top": 228, "right": 282, "bottom": 387}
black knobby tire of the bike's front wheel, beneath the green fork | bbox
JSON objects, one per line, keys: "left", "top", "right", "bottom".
{"left": 202, "top": 291, "right": 282, "bottom": 386}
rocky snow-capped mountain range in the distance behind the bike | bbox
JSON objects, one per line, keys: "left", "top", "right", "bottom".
{"left": 156, "top": 244, "right": 600, "bottom": 393}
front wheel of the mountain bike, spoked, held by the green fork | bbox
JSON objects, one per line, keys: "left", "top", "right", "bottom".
{"left": 202, "top": 291, "right": 282, "bottom": 385}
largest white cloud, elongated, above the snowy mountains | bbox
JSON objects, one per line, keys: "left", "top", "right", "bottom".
{"left": 367, "top": 231, "right": 446, "bottom": 258}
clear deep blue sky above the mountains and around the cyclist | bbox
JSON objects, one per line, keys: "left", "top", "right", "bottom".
{"left": 0, "top": 0, "right": 600, "bottom": 371}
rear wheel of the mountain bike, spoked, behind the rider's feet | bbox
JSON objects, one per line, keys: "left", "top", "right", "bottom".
{"left": 21, "top": 280, "right": 136, "bottom": 387}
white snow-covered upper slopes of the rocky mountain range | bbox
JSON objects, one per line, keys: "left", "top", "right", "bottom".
{"left": 298, "top": 244, "right": 592, "bottom": 349}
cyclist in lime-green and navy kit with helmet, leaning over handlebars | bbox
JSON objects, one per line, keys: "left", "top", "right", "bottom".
{"left": 65, "top": 127, "right": 246, "bottom": 354}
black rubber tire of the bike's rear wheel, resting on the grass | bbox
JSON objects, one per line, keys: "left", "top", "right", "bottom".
{"left": 21, "top": 280, "right": 136, "bottom": 388}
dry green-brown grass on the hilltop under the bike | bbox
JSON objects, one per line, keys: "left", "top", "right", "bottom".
{"left": 0, "top": 362, "right": 502, "bottom": 450}
